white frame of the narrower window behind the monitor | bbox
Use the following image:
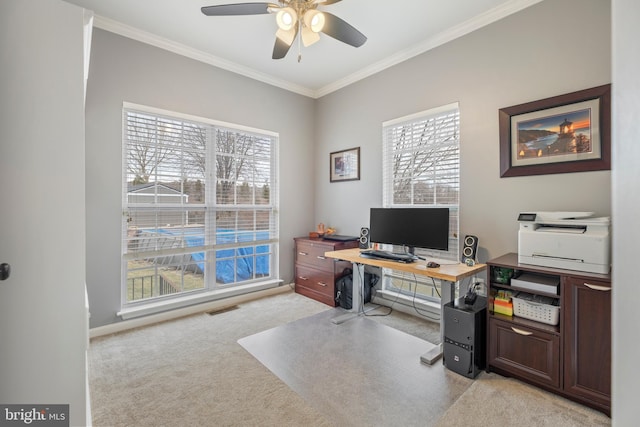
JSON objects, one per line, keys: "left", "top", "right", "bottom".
{"left": 382, "top": 102, "right": 460, "bottom": 311}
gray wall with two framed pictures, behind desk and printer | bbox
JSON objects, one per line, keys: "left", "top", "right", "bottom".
{"left": 315, "top": 0, "right": 611, "bottom": 261}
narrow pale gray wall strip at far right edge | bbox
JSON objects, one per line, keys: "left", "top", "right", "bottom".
{"left": 612, "top": 0, "right": 640, "bottom": 426}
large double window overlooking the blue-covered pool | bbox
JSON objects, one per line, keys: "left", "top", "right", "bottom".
{"left": 122, "top": 104, "right": 278, "bottom": 307}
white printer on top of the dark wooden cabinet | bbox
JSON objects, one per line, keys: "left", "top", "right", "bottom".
{"left": 518, "top": 212, "right": 611, "bottom": 274}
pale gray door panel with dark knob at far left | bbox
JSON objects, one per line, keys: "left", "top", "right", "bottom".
{"left": 0, "top": 0, "right": 90, "bottom": 426}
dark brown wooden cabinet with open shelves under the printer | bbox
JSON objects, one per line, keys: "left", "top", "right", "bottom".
{"left": 487, "top": 253, "right": 611, "bottom": 415}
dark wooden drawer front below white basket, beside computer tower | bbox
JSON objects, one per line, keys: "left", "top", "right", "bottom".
{"left": 489, "top": 318, "right": 561, "bottom": 388}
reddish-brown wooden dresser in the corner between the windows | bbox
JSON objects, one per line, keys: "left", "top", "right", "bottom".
{"left": 293, "top": 237, "right": 358, "bottom": 307}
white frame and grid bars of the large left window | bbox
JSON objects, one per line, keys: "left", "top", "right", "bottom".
{"left": 118, "top": 102, "right": 280, "bottom": 319}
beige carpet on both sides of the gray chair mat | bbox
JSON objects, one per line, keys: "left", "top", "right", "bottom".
{"left": 89, "top": 292, "right": 610, "bottom": 427}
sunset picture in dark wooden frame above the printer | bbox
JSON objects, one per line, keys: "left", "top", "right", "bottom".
{"left": 498, "top": 84, "right": 611, "bottom": 177}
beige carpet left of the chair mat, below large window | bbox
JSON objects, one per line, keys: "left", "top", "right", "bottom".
{"left": 89, "top": 293, "right": 330, "bottom": 427}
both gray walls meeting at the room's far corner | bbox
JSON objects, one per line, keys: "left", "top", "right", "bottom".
{"left": 86, "top": 0, "right": 611, "bottom": 327}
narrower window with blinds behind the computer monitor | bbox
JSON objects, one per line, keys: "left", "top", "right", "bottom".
{"left": 382, "top": 103, "right": 460, "bottom": 299}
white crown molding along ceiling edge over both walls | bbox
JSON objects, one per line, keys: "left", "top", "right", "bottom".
{"left": 94, "top": 0, "right": 544, "bottom": 99}
